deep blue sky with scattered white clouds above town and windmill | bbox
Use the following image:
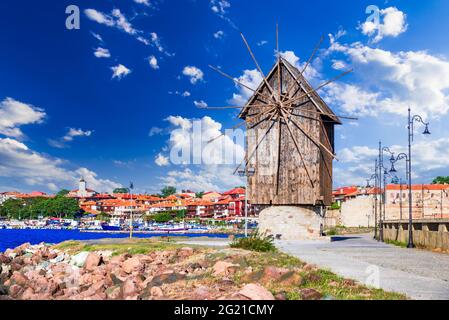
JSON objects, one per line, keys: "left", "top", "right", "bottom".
{"left": 0, "top": 0, "right": 449, "bottom": 192}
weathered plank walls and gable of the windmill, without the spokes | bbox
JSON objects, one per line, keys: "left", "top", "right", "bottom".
{"left": 240, "top": 58, "right": 340, "bottom": 205}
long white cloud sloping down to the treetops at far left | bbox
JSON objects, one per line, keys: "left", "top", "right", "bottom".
{"left": 0, "top": 138, "right": 119, "bottom": 191}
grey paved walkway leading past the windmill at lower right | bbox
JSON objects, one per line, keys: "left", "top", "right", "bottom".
{"left": 276, "top": 235, "right": 449, "bottom": 300}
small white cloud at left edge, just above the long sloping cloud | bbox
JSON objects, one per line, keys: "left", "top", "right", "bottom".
{"left": 0, "top": 98, "right": 45, "bottom": 138}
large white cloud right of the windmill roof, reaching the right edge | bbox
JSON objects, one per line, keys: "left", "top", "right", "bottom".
{"left": 328, "top": 39, "right": 449, "bottom": 117}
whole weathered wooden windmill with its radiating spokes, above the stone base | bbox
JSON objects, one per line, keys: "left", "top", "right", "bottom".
{"left": 201, "top": 24, "right": 352, "bottom": 206}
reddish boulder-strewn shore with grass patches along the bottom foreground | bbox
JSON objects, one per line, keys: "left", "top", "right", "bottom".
{"left": 0, "top": 242, "right": 406, "bottom": 300}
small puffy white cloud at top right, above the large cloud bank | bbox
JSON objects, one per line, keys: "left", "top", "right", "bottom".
{"left": 360, "top": 7, "right": 408, "bottom": 43}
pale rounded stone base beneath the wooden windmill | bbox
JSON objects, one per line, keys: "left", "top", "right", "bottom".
{"left": 259, "top": 206, "right": 323, "bottom": 240}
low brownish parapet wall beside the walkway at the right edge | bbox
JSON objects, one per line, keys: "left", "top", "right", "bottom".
{"left": 383, "top": 219, "right": 449, "bottom": 250}
